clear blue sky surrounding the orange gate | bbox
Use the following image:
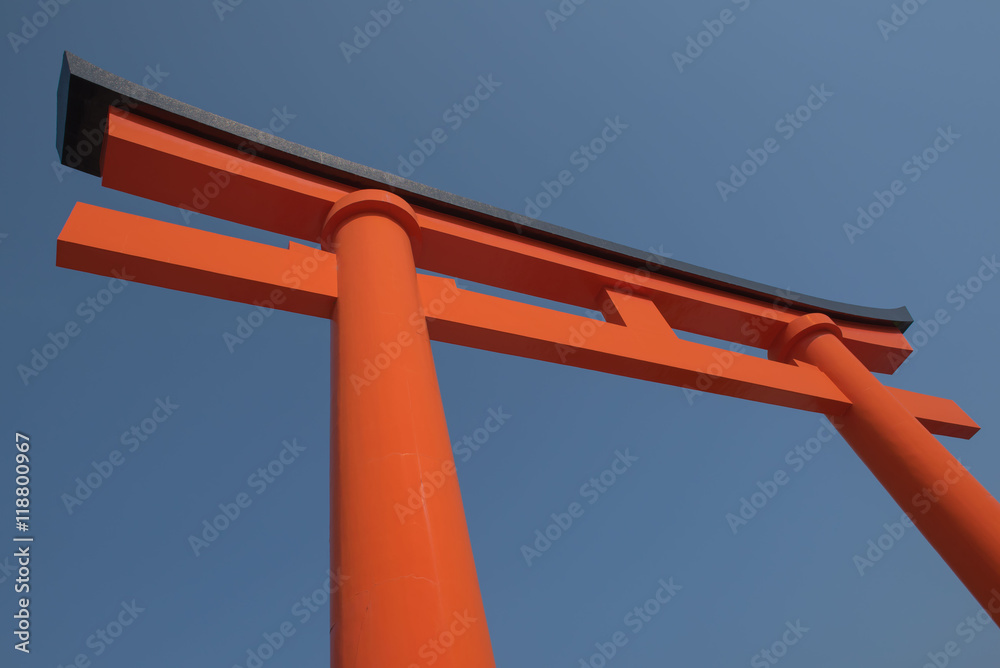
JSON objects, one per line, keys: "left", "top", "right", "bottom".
{"left": 0, "top": 0, "right": 1000, "bottom": 668}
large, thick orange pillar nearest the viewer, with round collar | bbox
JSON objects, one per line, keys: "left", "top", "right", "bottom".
{"left": 323, "top": 190, "right": 494, "bottom": 668}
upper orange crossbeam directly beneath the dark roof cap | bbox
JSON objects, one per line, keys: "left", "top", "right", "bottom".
{"left": 102, "top": 109, "right": 912, "bottom": 373}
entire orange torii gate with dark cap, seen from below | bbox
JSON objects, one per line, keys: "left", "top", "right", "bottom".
{"left": 56, "top": 53, "right": 1000, "bottom": 668}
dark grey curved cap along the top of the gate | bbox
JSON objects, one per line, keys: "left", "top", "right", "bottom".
{"left": 56, "top": 51, "right": 913, "bottom": 332}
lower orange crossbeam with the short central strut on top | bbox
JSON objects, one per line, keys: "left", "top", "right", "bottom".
{"left": 56, "top": 203, "right": 979, "bottom": 438}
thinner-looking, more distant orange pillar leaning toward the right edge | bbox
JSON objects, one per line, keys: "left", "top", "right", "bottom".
{"left": 770, "top": 314, "right": 1000, "bottom": 626}
